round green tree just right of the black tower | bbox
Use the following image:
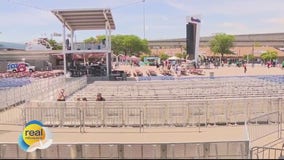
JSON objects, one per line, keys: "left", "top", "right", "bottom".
{"left": 210, "top": 33, "right": 235, "bottom": 59}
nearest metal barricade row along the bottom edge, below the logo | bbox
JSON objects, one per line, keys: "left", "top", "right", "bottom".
{"left": 0, "top": 141, "right": 249, "bottom": 159}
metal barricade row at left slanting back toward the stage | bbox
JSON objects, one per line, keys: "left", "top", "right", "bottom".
{"left": 0, "top": 76, "right": 87, "bottom": 110}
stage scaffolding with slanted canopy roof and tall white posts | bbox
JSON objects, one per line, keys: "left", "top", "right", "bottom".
{"left": 51, "top": 9, "right": 115, "bottom": 77}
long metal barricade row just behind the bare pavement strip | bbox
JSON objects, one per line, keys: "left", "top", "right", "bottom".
{"left": 12, "top": 98, "right": 283, "bottom": 127}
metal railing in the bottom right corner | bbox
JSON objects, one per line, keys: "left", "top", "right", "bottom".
{"left": 250, "top": 146, "right": 284, "bottom": 159}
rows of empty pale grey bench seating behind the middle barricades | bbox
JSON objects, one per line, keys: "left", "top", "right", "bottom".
{"left": 71, "top": 77, "right": 284, "bottom": 101}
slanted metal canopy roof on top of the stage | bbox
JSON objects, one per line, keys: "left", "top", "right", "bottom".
{"left": 51, "top": 9, "right": 115, "bottom": 31}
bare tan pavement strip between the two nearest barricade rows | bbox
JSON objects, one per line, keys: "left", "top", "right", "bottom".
{"left": 0, "top": 125, "right": 246, "bottom": 143}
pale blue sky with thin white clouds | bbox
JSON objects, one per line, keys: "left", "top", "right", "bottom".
{"left": 0, "top": 0, "right": 284, "bottom": 43}
